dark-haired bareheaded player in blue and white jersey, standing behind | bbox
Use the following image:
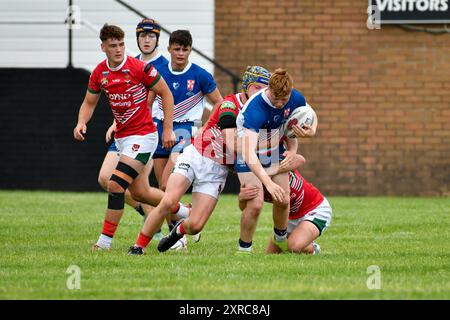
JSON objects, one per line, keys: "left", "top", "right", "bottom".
{"left": 153, "top": 30, "right": 222, "bottom": 190}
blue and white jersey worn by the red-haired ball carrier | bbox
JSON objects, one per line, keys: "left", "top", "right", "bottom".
{"left": 236, "top": 88, "right": 306, "bottom": 149}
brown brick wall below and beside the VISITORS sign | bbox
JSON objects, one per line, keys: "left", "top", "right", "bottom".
{"left": 215, "top": 0, "right": 450, "bottom": 196}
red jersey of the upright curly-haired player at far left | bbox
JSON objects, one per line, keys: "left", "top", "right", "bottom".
{"left": 88, "top": 56, "right": 161, "bottom": 138}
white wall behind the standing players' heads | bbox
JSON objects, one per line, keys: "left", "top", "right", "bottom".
{"left": 0, "top": 0, "right": 214, "bottom": 74}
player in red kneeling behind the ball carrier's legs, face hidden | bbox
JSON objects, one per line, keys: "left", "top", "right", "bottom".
{"left": 239, "top": 166, "right": 332, "bottom": 254}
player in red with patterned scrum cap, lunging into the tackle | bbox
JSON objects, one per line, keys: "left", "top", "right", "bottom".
{"left": 128, "top": 66, "right": 270, "bottom": 255}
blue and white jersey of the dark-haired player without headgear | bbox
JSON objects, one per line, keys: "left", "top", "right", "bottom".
{"left": 157, "top": 62, "right": 217, "bottom": 122}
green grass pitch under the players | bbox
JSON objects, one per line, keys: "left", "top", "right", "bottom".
{"left": 0, "top": 191, "right": 450, "bottom": 300}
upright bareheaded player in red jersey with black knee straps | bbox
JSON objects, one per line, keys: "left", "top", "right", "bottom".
{"left": 73, "top": 24, "right": 181, "bottom": 249}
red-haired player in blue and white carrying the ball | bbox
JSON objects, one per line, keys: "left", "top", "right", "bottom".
{"left": 235, "top": 69, "right": 317, "bottom": 252}
